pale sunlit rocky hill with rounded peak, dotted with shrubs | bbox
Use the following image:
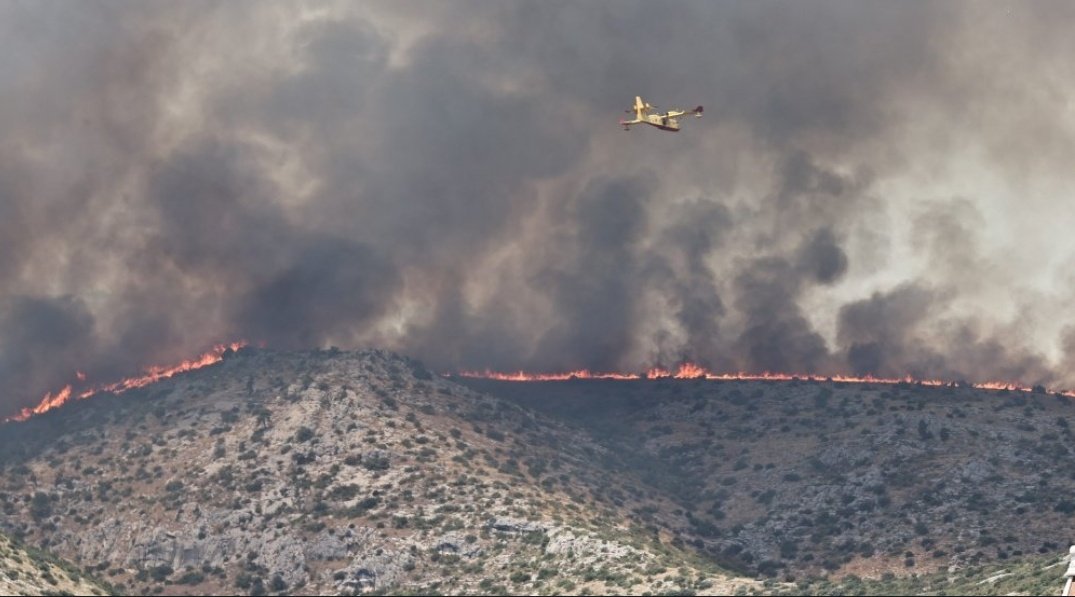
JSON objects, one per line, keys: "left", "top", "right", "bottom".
{"left": 0, "top": 350, "right": 757, "bottom": 594}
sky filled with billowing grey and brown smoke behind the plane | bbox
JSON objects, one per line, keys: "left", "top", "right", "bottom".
{"left": 0, "top": 0, "right": 1075, "bottom": 414}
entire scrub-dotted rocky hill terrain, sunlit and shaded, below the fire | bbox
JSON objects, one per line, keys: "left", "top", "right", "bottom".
{"left": 0, "top": 350, "right": 1075, "bottom": 594}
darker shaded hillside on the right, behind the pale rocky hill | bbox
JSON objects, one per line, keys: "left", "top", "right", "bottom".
{"left": 464, "top": 380, "right": 1075, "bottom": 581}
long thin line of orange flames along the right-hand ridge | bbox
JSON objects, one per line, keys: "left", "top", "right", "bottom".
{"left": 458, "top": 363, "right": 1075, "bottom": 398}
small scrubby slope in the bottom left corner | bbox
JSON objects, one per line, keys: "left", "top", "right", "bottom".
{"left": 0, "top": 534, "right": 112, "bottom": 595}
